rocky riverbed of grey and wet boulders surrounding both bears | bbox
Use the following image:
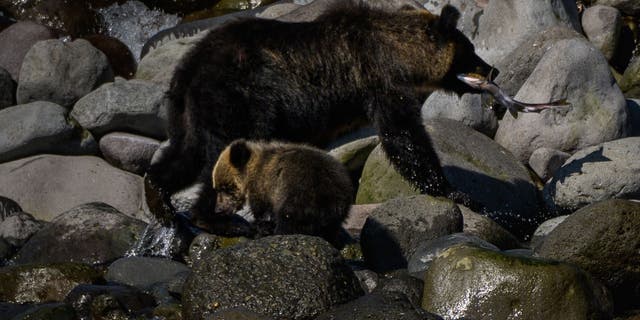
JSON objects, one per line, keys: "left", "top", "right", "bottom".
{"left": 0, "top": 0, "right": 640, "bottom": 320}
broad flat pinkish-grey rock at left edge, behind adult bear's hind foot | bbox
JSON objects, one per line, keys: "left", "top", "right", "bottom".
{"left": 0, "top": 155, "right": 143, "bottom": 221}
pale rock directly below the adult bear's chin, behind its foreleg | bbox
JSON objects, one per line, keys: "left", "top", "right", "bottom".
{"left": 422, "top": 92, "right": 498, "bottom": 137}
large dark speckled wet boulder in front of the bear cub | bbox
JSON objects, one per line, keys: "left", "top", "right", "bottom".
{"left": 182, "top": 235, "right": 362, "bottom": 319}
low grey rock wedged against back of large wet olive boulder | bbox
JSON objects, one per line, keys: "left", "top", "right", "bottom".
{"left": 407, "top": 232, "right": 500, "bottom": 279}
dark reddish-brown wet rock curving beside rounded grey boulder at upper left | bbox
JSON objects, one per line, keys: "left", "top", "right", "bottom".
{"left": 83, "top": 34, "right": 138, "bottom": 79}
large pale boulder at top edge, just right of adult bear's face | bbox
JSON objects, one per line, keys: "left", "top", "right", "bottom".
{"left": 473, "top": 0, "right": 582, "bottom": 64}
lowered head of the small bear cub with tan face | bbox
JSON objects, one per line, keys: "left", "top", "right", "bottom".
{"left": 212, "top": 140, "right": 252, "bottom": 214}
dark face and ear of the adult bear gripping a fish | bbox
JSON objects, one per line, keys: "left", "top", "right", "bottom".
{"left": 432, "top": 5, "right": 498, "bottom": 95}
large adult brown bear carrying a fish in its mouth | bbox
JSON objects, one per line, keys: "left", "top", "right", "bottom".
{"left": 146, "top": 2, "right": 490, "bottom": 232}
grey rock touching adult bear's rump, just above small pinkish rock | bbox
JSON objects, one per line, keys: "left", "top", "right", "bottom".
{"left": 71, "top": 79, "right": 167, "bottom": 139}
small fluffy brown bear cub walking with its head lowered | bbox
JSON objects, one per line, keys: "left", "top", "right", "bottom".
{"left": 212, "top": 139, "right": 354, "bottom": 247}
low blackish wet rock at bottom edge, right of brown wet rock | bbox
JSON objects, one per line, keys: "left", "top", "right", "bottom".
{"left": 65, "top": 285, "right": 156, "bottom": 319}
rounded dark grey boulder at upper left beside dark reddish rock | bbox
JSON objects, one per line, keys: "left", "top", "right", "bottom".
{"left": 16, "top": 39, "right": 113, "bottom": 107}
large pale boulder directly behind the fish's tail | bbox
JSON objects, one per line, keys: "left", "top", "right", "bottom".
{"left": 495, "top": 39, "right": 628, "bottom": 162}
